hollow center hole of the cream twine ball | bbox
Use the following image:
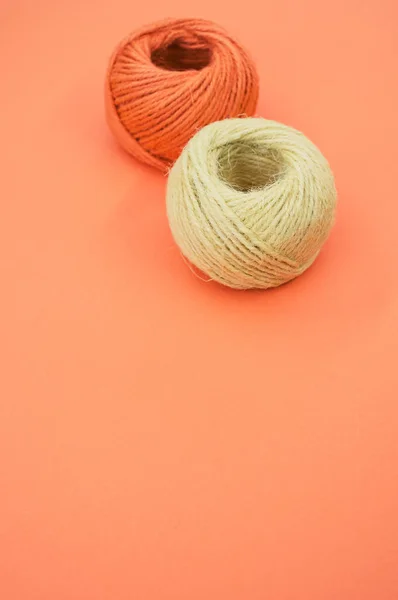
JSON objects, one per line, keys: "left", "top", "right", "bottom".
{"left": 218, "top": 142, "right": 286, "bottom": 192}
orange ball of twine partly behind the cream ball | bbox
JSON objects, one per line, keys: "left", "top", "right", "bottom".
{"left": 105, "top": 19, "right": 259, "bottom": 170}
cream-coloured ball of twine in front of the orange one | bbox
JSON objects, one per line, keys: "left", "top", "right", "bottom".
{"left": 167, "top": 118, "right": 336, "bottom": 289}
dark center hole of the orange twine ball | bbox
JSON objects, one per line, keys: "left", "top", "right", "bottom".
{"left": 151, "top": 38, "right": 211, "bottom": 71}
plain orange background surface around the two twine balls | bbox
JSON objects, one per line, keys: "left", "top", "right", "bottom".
{"left": 0, "top": 0, "right": 398, "bottom": 600}
